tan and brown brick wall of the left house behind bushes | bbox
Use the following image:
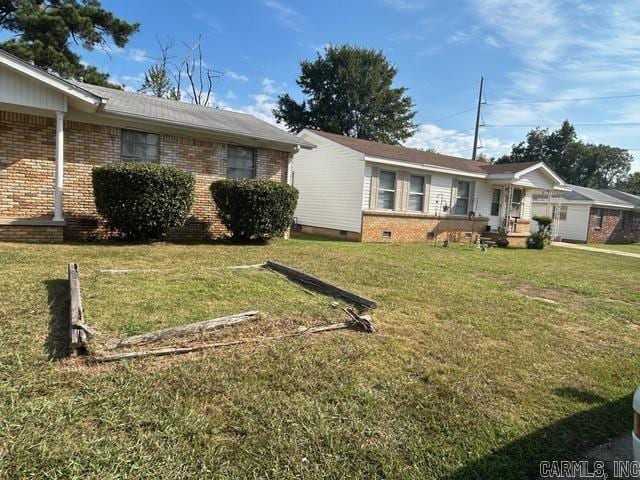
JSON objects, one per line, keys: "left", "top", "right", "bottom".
{"left": 0, "top": 111, "right": 289, "bottom": 240}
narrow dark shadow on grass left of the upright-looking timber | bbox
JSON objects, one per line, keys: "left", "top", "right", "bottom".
{"left": 44, "top": 279, "right": 71, "bottom": 360}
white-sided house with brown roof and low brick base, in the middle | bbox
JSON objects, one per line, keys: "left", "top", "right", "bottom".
{"left": 292, "top": 130, "right": 564, "bottom": 245}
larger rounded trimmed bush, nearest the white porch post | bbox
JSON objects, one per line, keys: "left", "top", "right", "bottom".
{"left": 93, "top": 163, "right": 196, "bottom": 241}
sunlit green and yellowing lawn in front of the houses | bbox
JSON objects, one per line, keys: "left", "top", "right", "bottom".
{"left": 0, "top": 239, "right": 640, "bottom": 479}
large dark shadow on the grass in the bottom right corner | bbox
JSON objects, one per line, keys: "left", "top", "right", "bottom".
{"left": 449, "top": 389, "right": 633, "bottom": 480}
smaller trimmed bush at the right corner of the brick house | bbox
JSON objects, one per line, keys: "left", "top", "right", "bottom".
{"left": 211, "top": 180, "right": 298, "bottom": 242}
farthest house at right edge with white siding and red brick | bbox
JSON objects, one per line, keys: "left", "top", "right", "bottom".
{"left": 533, "top": 185, "right": 640, "bottom": 243}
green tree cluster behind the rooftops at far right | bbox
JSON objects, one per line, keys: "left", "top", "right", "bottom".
{"left": 496, "top": 120, "right": 633, "bottom": 188}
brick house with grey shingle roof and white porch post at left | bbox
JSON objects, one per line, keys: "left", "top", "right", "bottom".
{"left": 0, "top": 51, "right": 313, "bottom": 241}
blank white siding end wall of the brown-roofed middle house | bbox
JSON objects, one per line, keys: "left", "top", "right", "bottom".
{"left": 292, "top": 131, "right": 365, "bottom": 233}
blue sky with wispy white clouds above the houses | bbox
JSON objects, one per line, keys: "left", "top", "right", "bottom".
{"left": 33, "top": 0, "right": 640, "bottom": 170}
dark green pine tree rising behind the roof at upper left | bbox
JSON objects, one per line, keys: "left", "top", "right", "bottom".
{"left": 0, "top": 0, "right": 140, "bottom": 88}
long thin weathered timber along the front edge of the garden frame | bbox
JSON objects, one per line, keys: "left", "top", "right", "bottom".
{"left": 91, "top": 322, "right": 354, "bottom": 363}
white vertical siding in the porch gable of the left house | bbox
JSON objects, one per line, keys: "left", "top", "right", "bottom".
{"left": 0, "top": 66, "right": 67, "bottom": 112}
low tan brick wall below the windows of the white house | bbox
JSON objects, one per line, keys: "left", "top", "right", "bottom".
{"left": 362, "top": 212, "right": 488, "bottom": 242}
